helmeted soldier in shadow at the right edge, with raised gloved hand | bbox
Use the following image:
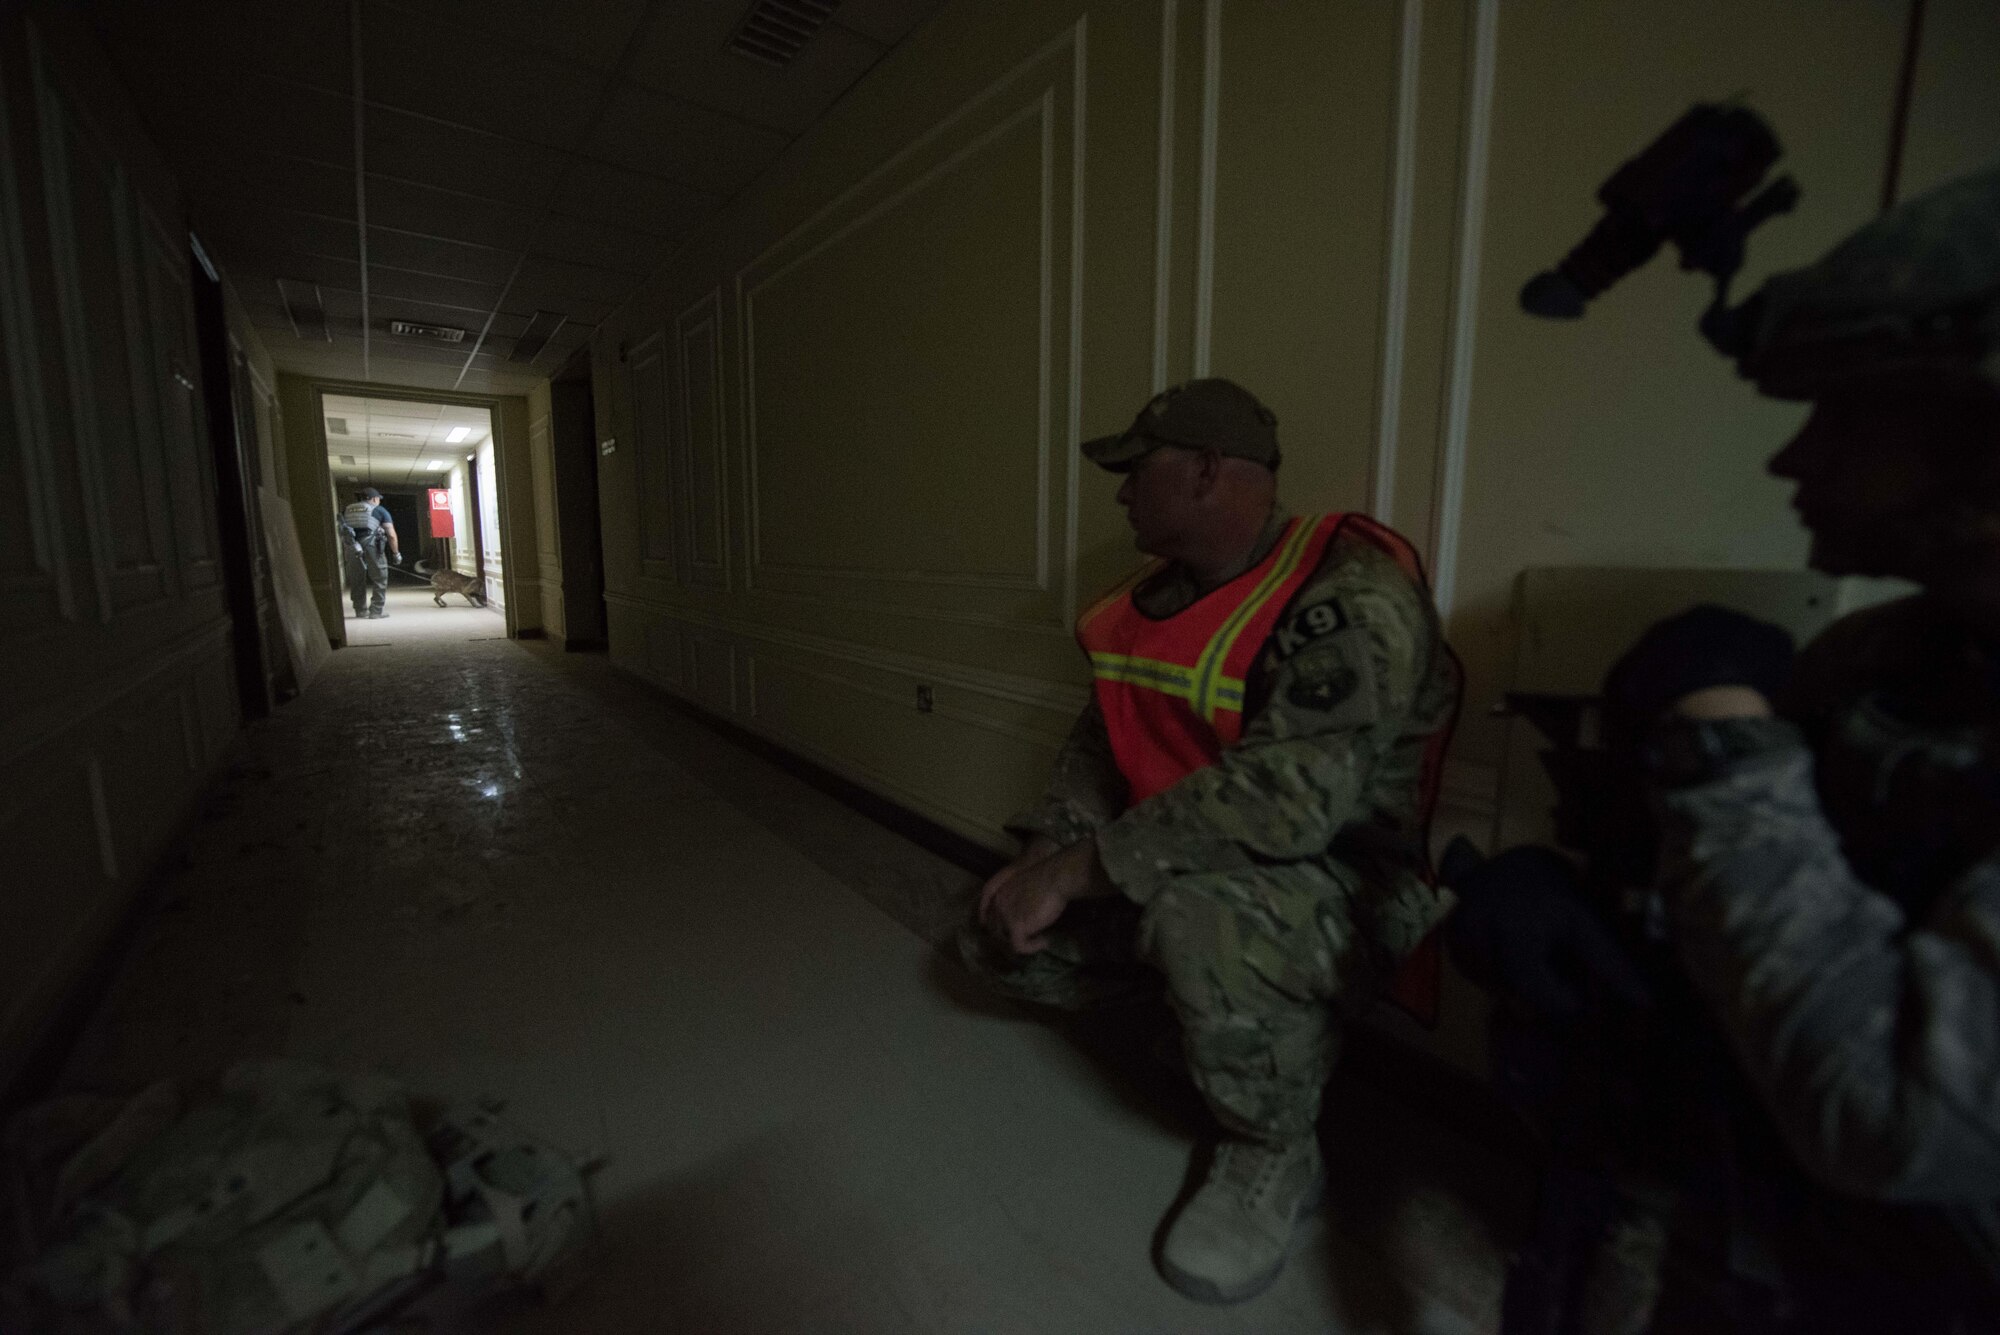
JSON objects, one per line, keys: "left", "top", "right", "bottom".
{"left": 1456, "top": 161, "right": 2000, "bottom": 1335}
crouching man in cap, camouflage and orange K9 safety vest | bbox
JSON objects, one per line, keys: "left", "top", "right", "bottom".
{"left": 960, "top": 380, "right": 1460, "bottom": 1303}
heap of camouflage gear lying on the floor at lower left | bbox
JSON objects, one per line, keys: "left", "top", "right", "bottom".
{"left": 0, "top": 1061, "right": 594, "bottom": 1335}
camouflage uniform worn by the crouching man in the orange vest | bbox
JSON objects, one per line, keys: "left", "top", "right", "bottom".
{"left": 960, "top": 510, "right": 1458, "bottom": 1139}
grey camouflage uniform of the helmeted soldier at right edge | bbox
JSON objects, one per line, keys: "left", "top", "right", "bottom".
{"left": 1664, "top": 596, "right": 2000, "bottom": 1329}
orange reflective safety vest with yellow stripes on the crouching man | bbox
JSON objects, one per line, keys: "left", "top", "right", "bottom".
{"left": 1076, "top": 514, "right": 1450, "bottom": 1023}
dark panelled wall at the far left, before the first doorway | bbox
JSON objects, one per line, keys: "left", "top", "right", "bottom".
{"left": 0, "top": 10, "right": 270, "bottom": 1095}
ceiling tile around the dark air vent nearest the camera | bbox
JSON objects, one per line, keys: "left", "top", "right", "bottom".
{"left": 632, "top": 6, "right": 884, "bottom": 136}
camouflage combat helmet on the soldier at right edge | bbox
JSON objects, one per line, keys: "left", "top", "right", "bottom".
{"left": 1732, "top": 166, "right": 2000, "bottom": 400}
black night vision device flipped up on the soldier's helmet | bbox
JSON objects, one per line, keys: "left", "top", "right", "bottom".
{"left": 1520, "top": 102, "right": 1798, "bottom": 356}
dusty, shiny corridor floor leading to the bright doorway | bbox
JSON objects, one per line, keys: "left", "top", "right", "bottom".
{"left": 50, "top": 594, "right": 1520, "bottom": 1335}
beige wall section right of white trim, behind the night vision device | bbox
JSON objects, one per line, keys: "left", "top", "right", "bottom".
{"left": 1440, "top": 0, "right": 1906, "bottom": 765}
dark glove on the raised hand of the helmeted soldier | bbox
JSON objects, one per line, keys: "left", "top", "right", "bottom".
{"left": 1604, "top": 604, "right": 1792, "bottom": 735}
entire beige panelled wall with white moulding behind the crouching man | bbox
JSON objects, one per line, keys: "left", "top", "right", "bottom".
{"left": 594, "top": 0, "right": 1992, "bottom": 841}
